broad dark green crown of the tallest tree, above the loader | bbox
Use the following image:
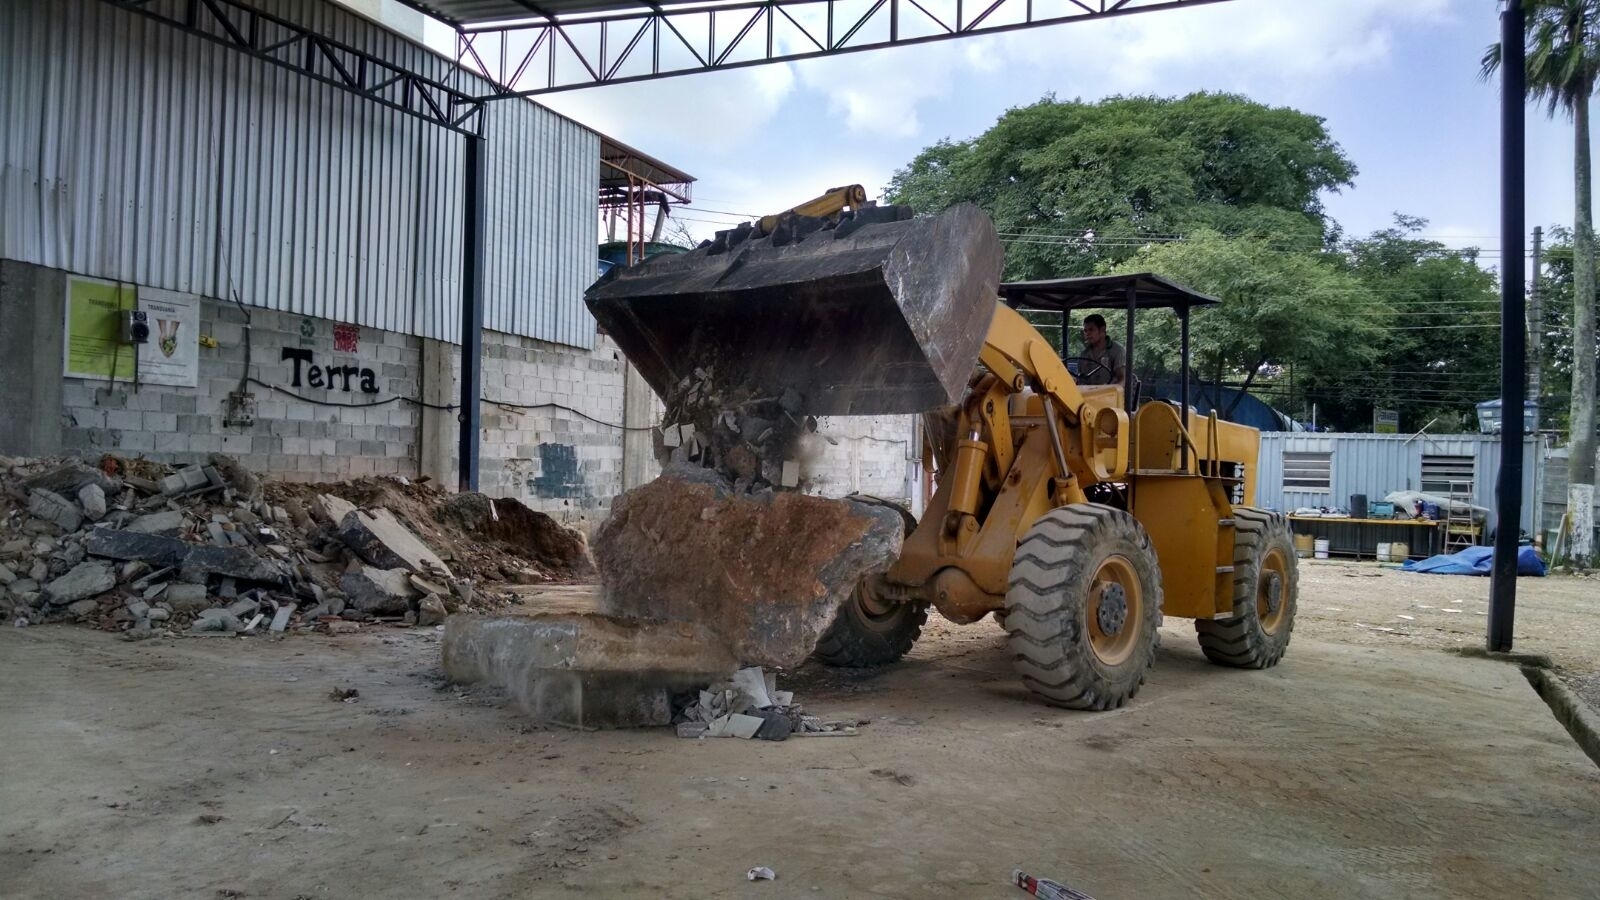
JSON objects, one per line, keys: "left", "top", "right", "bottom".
{"left": 885, "top": 93, "right": 1355, "bottom": 279}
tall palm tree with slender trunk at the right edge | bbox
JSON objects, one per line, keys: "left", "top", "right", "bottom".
{"left": 1483, "top": 0, "right": 1600, "bottom": 567}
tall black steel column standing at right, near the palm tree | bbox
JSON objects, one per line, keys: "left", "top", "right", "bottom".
{"left": 1488, "top": 0, "right": 1528, "bottom": 652}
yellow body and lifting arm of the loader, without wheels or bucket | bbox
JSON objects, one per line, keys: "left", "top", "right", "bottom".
{"left": 878, "top": 304, "right": 1261, "bottom": 621}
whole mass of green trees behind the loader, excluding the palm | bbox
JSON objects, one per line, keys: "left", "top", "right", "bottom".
{"left": 886, "top": 93, "right": 1499, "bottom": 431}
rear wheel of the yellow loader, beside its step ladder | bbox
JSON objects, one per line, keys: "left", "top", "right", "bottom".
{"left": 1195, "top": 508, "right": 1299, "bottom": 669}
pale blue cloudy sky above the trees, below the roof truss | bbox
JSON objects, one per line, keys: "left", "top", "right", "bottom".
{"left": 384, "top": 0, "right": 1571, "bottom": 264}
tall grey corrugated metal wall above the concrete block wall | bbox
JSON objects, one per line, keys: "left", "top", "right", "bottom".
{"left": 0, "top": 0, "right": 600, "bottom": 348}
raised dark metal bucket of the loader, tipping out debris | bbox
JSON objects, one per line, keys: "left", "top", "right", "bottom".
{"left": 584, "top": 205, "right": 1002, "bottom": 415}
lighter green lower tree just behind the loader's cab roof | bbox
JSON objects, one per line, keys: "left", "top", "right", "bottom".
{"left": 1115, "top": 229, "right": 1387, "bottom": 413}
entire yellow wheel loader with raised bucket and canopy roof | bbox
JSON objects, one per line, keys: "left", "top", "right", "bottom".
{"left": 586, "top": 192, "right": 1298, "bottom": 709}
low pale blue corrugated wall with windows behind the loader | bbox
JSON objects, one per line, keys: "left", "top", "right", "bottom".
{"left": 1256, "top": 432, "right": 1544, "bottom": 533}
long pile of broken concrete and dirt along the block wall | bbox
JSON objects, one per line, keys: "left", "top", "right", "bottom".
{"left": 0, "top": 455, "right": 592, "bottom": 637}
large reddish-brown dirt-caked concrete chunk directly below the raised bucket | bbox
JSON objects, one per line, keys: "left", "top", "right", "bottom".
{"left": 595, "top": 469, "right": 904, "bottom": 666}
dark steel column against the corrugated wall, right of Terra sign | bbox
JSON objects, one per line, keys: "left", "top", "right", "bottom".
{"left": 456, "top": 138, "right": 488, "bottom": 490}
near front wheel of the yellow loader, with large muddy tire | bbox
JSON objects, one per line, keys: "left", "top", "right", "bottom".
{"left": 1005, "top": 503, "right": 1162, "bottom": 709}
